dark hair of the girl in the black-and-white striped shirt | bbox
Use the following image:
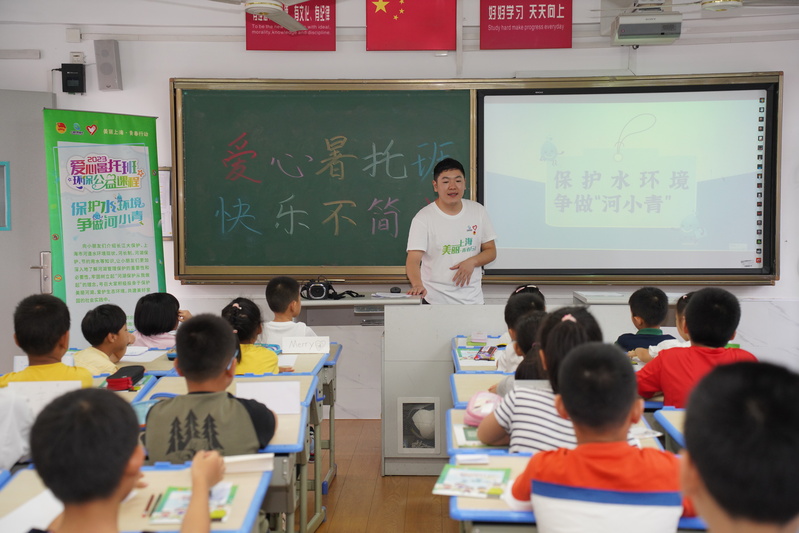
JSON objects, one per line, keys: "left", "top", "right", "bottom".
{"left": 538, "top": 307, "right": 604, "bottom": 393}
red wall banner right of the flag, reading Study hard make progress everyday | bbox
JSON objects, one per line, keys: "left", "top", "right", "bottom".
{"left": 480, "top": 0, "right": 572, "bottom": 50}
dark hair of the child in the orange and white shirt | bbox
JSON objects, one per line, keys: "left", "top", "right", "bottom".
{"left": 558, "top": 342, "right": 638, "bottom": 431}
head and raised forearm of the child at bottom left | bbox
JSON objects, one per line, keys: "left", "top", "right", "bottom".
{"left": 30, "top": 389, "right": 225, "bottom": 533}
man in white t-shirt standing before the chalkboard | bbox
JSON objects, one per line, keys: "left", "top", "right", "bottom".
{"left": 405, "top": 158, "right": 497, "bottom": 304}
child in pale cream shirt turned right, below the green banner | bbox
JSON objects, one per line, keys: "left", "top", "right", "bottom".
{"left": 74, "top": 304, "right": 133, "bottom": 376}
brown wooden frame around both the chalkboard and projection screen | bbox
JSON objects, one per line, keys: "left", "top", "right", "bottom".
{"left": 170, "top": 72, "right": 783, "bottom": 285}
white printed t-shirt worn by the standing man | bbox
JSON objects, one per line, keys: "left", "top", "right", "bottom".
{"left": 407, "top": 200, "right": 496, "bottom": 304}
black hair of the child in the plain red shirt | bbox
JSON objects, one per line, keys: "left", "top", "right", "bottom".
{"left": 685, "top": 287, "right": 741, "bottom": 348}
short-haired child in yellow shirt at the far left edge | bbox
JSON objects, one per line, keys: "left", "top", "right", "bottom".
{"left": 0, "top": 294, "right": 92, "bottom": 387}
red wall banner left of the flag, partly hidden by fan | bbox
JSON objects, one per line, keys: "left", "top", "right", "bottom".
{"left": 246, "top": 0, "right": 336, "bottom": 51}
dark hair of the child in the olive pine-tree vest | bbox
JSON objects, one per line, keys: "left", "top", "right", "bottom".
{"left": 175, "top": 314, "right": 239, "bottom": 381}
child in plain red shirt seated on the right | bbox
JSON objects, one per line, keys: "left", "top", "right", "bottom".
{"left": 636, "top": 287, "right": 757, "bottom": 407}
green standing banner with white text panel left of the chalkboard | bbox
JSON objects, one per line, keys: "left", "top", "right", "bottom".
{"left": 44, "top": 109, "right": 165, "bottom": 347}
